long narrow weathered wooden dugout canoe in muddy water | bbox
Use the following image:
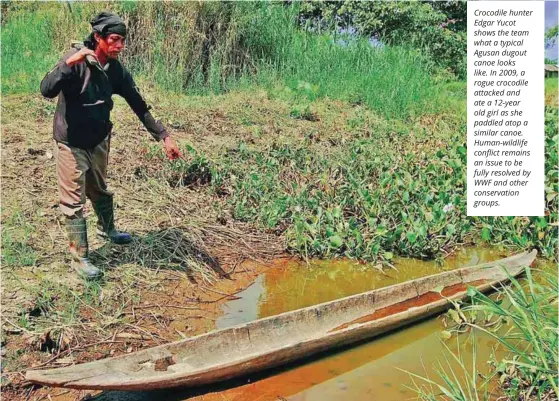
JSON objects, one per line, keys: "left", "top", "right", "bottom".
{"left": 26, "top": 250, "right": 537, "bottom": 390}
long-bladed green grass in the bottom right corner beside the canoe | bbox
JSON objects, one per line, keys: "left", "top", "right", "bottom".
{"left": 412, "top": 268, "right": 559, "bottom": 401}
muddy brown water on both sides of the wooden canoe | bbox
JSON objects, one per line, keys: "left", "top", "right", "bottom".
{"left": 95, "top": 249, "right": 552, "bottom": 401}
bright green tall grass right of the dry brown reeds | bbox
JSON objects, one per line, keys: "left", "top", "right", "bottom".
{"left": 236, "top": 3, "right": 440, "bottom": 118}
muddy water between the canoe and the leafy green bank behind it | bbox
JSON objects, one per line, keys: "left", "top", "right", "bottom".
{"left": 216, "top": 249, "right": 507, "bottom": 329}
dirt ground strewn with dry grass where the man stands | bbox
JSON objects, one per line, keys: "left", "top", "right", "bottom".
{"left": 1, "top": 83, "right": 324, "bottom": 400}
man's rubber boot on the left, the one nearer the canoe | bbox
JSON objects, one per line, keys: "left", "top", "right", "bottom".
{"left": 66, "top": 217, "right": 102, "bottom": 280}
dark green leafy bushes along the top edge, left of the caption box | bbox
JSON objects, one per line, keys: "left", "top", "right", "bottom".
{"left": 301, "top": 0, "right": 467, "bottom": 79}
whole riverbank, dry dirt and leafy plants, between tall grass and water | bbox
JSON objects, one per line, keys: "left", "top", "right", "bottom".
{"left": 2, "top": 82, "right": 557, "bottom": 399}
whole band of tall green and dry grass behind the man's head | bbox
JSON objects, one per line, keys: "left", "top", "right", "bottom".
{"left": 2, "top": 2, "right": 443, "bottom": 118}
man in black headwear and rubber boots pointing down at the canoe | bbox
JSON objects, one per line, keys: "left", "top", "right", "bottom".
{"left": 41, "top": 12, "right": 181, "bottom": 279}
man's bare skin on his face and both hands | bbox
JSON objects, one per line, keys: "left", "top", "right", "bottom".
{"left": 66, "top": 33, "right": 182, "bottom": 160}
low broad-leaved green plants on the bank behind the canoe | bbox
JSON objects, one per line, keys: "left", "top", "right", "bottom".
{"left": 155, "top": 102, "right": 558, "bottom": 260}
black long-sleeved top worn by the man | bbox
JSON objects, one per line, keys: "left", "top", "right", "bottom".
{"left": 41, "top": 49, "right": 168, "bottom": 149}
